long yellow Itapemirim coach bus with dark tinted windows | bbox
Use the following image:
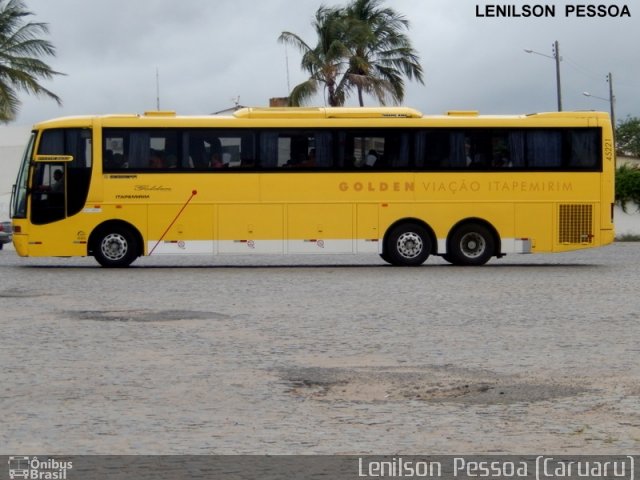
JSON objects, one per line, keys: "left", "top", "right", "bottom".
{"left": 11, "top": 107, "right": 614, "bottom": 267}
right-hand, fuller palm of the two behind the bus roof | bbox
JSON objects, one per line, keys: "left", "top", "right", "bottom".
{"left": 345, "top": 0, "right": 424, "bottom": 106}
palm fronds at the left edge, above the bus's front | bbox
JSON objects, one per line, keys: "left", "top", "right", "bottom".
{"left": 0, "top": 0, "right": 62, "bottom": 123}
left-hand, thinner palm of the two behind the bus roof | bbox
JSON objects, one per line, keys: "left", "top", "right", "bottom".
{"left": 278, "top": 6, "right": 349, "bottom": 107}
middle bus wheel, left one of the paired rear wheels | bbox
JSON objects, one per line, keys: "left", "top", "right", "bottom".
{"left": 385, "top": 223, "right": 431, "bottom": 267}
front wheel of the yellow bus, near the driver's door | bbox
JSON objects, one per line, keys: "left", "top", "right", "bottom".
{"left": 93, "top": 225, "right": 138, "bottom": 268}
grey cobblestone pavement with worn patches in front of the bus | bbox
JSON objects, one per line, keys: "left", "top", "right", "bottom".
{"left": 0, "top": 243, "right": 640, "bottom": 455}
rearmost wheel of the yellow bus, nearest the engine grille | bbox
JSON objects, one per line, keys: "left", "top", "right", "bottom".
{"left": 445, "top": 223, "right": 495, "bottom": 266}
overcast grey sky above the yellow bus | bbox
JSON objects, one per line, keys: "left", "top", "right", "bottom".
{"left": 13, "top": 0, "right": 640, "bottom": 125}
